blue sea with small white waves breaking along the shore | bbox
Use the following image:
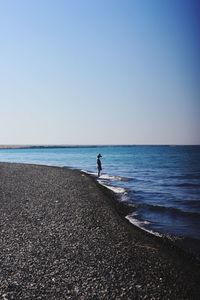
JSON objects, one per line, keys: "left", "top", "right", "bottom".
{"left": 0, "top": 145, "right": 200, "bottom": 253}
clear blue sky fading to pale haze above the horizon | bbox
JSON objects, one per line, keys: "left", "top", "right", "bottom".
{"left": 0, "top": 0, "right": 200, "bottom": 144}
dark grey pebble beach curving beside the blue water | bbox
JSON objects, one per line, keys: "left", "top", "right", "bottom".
{"left": 0, "top": 163, "right": 200, "bottom": 300}
